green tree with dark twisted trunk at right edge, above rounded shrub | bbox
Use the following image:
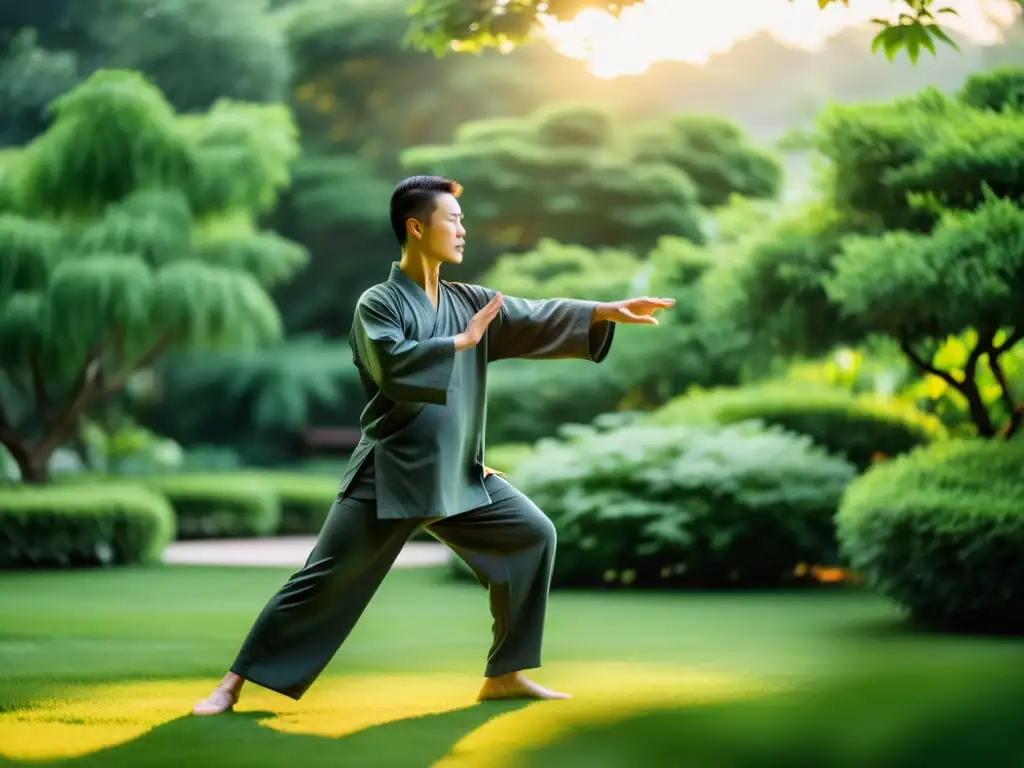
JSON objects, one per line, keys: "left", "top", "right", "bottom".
{"left": 824, "top": 193, "right": 1024, "bottom": 437}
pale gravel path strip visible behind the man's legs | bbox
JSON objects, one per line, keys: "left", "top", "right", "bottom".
{"left": 164, "top": 536, "right": 452, "bottom": 568}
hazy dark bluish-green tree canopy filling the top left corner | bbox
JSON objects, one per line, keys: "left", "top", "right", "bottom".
{"left": 0, "top": 0, "right": 291, "bottom": 145}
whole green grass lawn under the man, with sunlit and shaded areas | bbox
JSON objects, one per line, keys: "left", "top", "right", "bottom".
{"left": 0, "top": 566, "right": 1024, "bottom": 768}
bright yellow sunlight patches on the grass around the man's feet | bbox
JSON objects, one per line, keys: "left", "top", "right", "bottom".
{"left": 0, "top": 664, "right": 777, "bottom": 768}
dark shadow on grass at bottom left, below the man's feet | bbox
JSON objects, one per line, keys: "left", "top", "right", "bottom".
{"left": 6, "top": 701, "right": 529, "bottom": 768}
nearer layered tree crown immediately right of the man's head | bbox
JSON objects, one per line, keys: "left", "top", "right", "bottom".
{"left": 401, "top": 104, "right": 703, "bottom": 259}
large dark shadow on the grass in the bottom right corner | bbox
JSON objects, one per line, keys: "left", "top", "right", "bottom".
{"left": 517, "top": 667, "right": 1024, "bottom": 768}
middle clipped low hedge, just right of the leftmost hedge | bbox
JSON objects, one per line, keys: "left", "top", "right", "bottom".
{"left": 141, "top": 473, "right": 281, "bottom": 539}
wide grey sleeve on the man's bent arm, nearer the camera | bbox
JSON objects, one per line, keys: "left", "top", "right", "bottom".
{"left": 352, "top": 296, "right": 456, "bottom": 404}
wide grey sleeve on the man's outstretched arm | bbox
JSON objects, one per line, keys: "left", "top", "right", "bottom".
{"left": 487, "top": 296, "right": 615, "bottom": 362}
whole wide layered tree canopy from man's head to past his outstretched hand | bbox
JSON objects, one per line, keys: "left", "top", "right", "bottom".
{"left": 402, "top": 104, "right": 781, "bottom": 264}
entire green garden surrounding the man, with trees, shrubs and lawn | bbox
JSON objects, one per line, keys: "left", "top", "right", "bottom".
{"left": 0, "top": 0, "right": 1024, "bottom": 768}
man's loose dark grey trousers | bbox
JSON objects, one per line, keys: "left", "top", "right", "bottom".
{"left": 230, "top": 475, "right": 555, "bottom": 699}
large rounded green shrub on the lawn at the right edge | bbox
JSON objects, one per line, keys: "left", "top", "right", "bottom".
{"left": 837, "top": 439, "right": 1024, "bottom": 632}
